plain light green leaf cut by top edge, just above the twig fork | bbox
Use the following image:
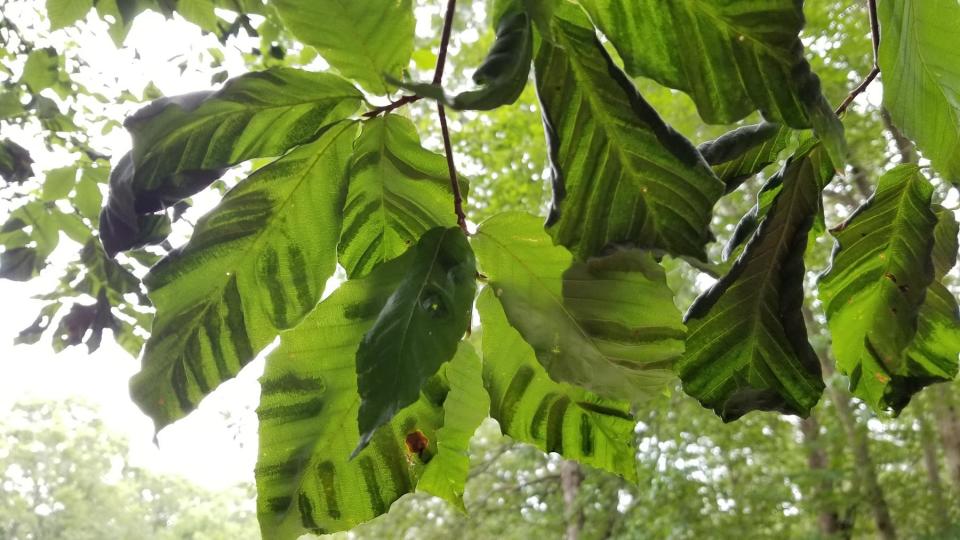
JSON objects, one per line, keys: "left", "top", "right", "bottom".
{"left": 273, "top": 0, "right": 415, "bottom": 94}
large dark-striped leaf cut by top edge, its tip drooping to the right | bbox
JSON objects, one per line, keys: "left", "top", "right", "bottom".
{"left": 580, "top": 0, "right": 845, "bottom": 163}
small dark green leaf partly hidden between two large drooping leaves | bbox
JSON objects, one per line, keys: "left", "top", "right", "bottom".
{"left": 697, "top": 122, "right": 793, "bottom": 193}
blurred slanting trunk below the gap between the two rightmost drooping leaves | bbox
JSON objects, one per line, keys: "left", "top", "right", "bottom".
{"left": 820, "top": 356, "right": 897, "bottom": 540}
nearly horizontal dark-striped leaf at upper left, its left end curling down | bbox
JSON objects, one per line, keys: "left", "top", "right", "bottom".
{"left": 124, "top": 68, "right": 362, "bottom": 213}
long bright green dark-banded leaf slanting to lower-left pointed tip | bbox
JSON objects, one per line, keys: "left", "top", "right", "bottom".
{"left": 125, "top": 122, "right": 356, "bottom": 430}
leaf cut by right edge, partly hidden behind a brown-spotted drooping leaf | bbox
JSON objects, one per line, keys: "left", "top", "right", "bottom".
{"left": 906, "top": 206, "right": 960, "bottom": 384}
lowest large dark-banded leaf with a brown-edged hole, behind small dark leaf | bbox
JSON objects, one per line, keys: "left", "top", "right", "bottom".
{"left": 256, "top": 251, "right": 482, "bottom": 540}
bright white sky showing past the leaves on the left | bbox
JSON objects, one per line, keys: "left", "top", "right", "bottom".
{"left": 0, "top": 2, "right": 262, "bottom": 488}
